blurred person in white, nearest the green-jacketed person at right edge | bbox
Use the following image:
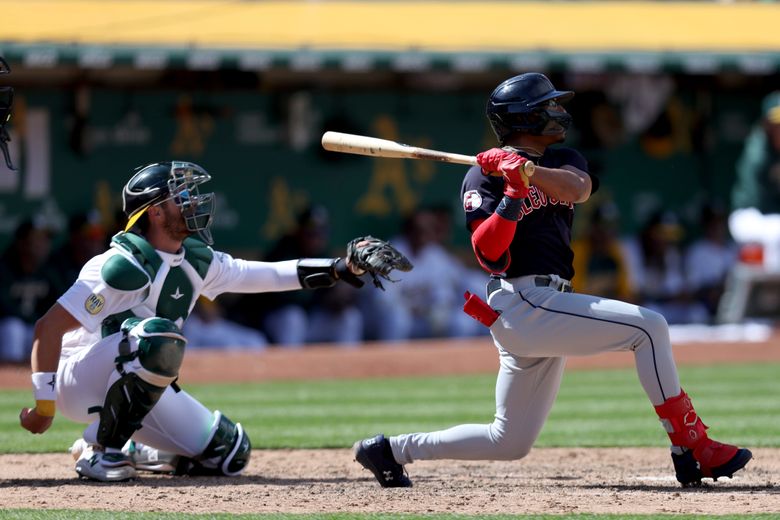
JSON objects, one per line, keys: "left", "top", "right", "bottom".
{"left": 685, "top": 204, "right": 739, "bottom": 320}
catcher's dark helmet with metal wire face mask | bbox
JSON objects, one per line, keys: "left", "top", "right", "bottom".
{"left": 122, "top": 161, "right": 214, "bottom": 245}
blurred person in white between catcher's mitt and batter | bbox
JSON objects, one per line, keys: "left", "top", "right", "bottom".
{"left": 361, "top": 208, "right": 486, "bottom": 341}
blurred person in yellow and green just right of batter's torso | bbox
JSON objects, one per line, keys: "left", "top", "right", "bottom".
{"left": 572, "top": 202, "right": 636, "bottom": 302}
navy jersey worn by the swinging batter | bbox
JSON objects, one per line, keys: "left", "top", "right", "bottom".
{"left": 461, "top": 148, "right": 599, "bottom": 280}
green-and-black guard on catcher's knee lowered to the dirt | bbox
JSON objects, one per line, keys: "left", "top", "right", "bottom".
{"left": 176, "top": 410, "right": 252, "bottom": 477}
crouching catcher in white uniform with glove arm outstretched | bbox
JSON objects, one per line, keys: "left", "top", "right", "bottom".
{"left": 20, "top": 161, "right": 411, "bottom": 481}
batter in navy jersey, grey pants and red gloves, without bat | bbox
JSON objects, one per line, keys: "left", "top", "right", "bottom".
{"left": 354, "top": 73, "right": 752, "bottom": 487}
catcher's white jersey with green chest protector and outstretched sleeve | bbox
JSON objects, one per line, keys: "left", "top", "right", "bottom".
{"left": 57, "top": 233, "right": 301, "bottom": 357}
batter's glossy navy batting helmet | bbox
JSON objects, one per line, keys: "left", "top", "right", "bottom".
{"left": 485, "top": 72, "right": 574, "bottom": 144}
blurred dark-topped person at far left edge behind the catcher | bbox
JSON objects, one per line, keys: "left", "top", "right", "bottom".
{"left": 0, "top": 215, "right": 59, "bottom": 363}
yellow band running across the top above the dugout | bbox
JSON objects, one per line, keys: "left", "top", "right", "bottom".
{"left": 0, "top": 0, "right": 780, "bottom": 52}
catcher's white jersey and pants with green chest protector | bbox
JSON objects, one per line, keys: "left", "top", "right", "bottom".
{"left": 57, "top": 233, "right": 301, "bottom": 457}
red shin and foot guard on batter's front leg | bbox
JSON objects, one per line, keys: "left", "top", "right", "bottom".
{"left": 655, "top": 391, "right": 739, "bottom": 477}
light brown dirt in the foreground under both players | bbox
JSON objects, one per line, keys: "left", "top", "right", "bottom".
{"left": 0, "top": 448, "right": 780, "bottom": 514}
